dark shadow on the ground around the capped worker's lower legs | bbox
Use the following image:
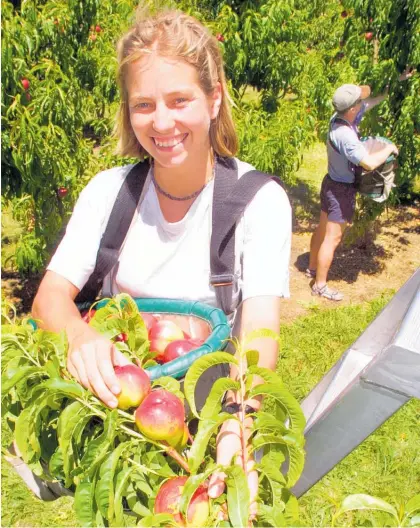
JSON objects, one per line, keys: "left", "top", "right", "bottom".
{"left": 294, "top": 235, "right": 392, "bottom": 284}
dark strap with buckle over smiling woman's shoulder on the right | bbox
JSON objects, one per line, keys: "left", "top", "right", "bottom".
{"left": 210, "top": 161, "right": 283, "bottom": 315}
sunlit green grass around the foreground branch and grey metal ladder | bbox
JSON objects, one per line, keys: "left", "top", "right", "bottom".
{"left": 2, "top": 292, "right": 420, "bottom": 527}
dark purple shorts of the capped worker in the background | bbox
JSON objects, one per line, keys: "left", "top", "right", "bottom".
{"left": 321, "top": 174, "right": 356, "bottom": 224}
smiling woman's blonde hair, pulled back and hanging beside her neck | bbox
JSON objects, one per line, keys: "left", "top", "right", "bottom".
{"left": 114, "top": 10, "right": 238, "bottom": 159}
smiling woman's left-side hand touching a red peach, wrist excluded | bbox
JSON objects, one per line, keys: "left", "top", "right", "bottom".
{"left": 67, "top": 320, "right": 130, "bottom": 408}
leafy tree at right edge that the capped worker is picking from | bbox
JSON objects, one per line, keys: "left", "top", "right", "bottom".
{"left": 343, "top": 0, "right": 420, "bottom": 200}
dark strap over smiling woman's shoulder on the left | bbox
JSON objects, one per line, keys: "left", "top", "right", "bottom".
{"left": 75, "top": 161, "right": 150, "bottom": 302}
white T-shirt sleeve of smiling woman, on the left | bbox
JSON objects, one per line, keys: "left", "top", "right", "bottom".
{"left": 47, "top": 167, "right": 132, "bottom": 290}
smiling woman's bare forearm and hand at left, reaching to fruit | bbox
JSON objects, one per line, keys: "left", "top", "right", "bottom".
{"left": 32, "top": 271, "right": 129, "bottom": 407}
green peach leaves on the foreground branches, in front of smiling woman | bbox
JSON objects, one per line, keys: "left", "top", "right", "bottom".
{"left": 2, "top": 295, "right": 305, "bottom": 526}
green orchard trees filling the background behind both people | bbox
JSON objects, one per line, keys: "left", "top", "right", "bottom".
{"left": 2, "top": 0, "right": 420, "bottom": 273}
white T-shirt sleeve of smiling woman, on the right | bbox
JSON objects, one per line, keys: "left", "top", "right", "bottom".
{"left": 242, "top": 182, "right": 292, "bottom": 300}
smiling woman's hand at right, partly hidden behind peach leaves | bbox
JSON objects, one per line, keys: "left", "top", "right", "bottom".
{"left": 208, "top": 417, "right": 258, "bottom": 519}
